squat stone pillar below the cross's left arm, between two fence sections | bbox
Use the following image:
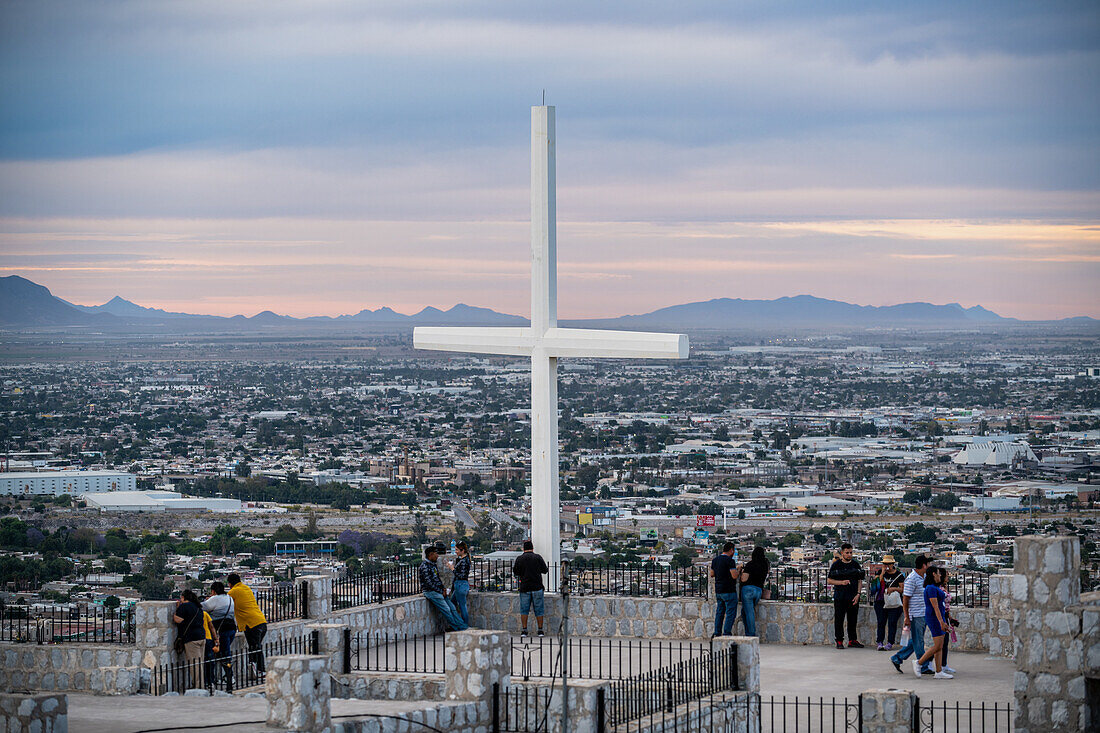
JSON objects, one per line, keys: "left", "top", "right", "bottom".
{"left": 443, "top": 628, "right": 512, "bottom": 701}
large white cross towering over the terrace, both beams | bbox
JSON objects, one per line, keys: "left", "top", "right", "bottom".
{"left": 413, "top": 106, "right": 688, "bottom": 590}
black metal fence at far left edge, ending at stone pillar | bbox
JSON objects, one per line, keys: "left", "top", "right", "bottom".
{"left": 0, "top": 605, "right": 135, "bottom": 644}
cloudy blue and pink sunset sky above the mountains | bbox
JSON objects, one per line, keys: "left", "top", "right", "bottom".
{"left": 0, "top": 0, "right": 1100, "bottom": 319}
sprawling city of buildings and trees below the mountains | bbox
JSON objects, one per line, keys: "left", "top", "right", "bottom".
{"left": 0, "top": 331, "right": 1100, "bottom": 617}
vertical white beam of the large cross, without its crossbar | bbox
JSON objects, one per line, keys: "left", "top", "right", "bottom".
{"left": 531, "top": 106, "right": 561, "bottom": 591}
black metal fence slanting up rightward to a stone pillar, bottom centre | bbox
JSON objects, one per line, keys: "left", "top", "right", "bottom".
{"left": 606, "top": 646, "right": 739, "bottom": 726}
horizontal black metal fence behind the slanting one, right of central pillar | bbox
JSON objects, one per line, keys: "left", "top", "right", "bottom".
{"left": 512, "top": 636, "right": 711, "bottom": 680}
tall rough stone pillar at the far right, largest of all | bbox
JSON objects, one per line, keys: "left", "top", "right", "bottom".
{"left": 1012, "top": 536, "right": 1088, "bottom": 733}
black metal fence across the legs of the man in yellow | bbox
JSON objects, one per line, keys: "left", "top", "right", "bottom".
{"left": 149, "top": 633, "right": 319, "bottom": 694}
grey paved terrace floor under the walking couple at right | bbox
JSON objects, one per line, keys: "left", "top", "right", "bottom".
{"left": 760, "top": 644, "right": 1015, "bottom": 704}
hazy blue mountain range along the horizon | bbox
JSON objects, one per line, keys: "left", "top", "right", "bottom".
{"left": 0, "top": 275, "right": 1100, "bottom": 332}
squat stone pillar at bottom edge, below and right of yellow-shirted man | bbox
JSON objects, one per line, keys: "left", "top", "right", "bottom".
{"left": 265, "top": 654, "right": 332, "bottom": 733}
